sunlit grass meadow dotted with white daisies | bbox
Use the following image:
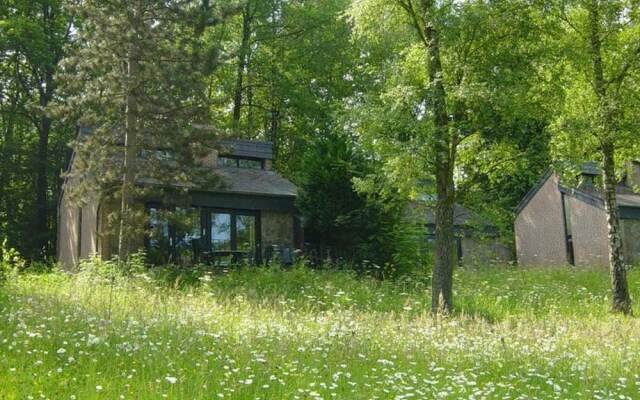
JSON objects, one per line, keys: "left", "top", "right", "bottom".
{"left": 0, "top": 267, "right": 640, "bottom": 399}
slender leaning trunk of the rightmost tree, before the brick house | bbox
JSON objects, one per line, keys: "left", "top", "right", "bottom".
{"left": 589, "top": 1, "right": 632, "bottom": 314}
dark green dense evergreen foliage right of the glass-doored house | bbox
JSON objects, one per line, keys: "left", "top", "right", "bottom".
{"left": 298, "top": 134, "right": 422, "bottom": 274}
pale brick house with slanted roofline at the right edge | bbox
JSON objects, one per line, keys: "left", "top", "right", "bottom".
{"left": 514, "top": 162, "right": 640, "bottom": 266}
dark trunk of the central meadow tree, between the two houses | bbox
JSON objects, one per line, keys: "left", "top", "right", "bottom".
{"left": 424, "top": 20, "right": 455, "bottom": 313}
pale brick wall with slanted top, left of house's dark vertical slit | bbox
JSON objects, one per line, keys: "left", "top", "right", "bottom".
{"left": 515, "top": 175, "right": 567, "bottom": 266}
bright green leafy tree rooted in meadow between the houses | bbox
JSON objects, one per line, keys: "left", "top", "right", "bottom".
{"left": 350, "top": 0, "right": 552, "bottom": 313}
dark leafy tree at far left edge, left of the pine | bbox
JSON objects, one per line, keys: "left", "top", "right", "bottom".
{"left": 0, "top": 0, "right": 75, "bottom": 257}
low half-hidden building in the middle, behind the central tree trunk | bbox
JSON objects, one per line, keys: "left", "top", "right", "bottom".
{"left": 409, "top": 202, "right": 513, "bottom": 265}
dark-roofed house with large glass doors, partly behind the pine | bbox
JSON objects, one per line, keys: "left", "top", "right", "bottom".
{"left": 57, "top": 140, "right": 302, "bottom": 268}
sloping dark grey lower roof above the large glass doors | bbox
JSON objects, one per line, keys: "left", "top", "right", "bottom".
{"left": 215, "top": 168, "right": 297, "bottom": 197}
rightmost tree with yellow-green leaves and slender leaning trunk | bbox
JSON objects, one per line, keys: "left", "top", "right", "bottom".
{"left": 554, "top": 0, "right": 640, "bottom": 314}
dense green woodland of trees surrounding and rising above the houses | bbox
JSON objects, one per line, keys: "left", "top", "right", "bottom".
{"left": 0, "top": 0, "right": 640, "bottom": 312}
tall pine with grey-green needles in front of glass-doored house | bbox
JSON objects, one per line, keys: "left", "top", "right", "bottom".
{"left": 59, "top": 0, "right": 235, "bottom": 259}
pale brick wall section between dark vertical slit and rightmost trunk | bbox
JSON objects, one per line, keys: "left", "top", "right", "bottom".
{"left": 566, "top": 196, "right": 609, "bottom": 267}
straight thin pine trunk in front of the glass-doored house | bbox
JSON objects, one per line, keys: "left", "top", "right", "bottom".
{"left": 118, "top": 27, "right": 139, "bottom": 260}
